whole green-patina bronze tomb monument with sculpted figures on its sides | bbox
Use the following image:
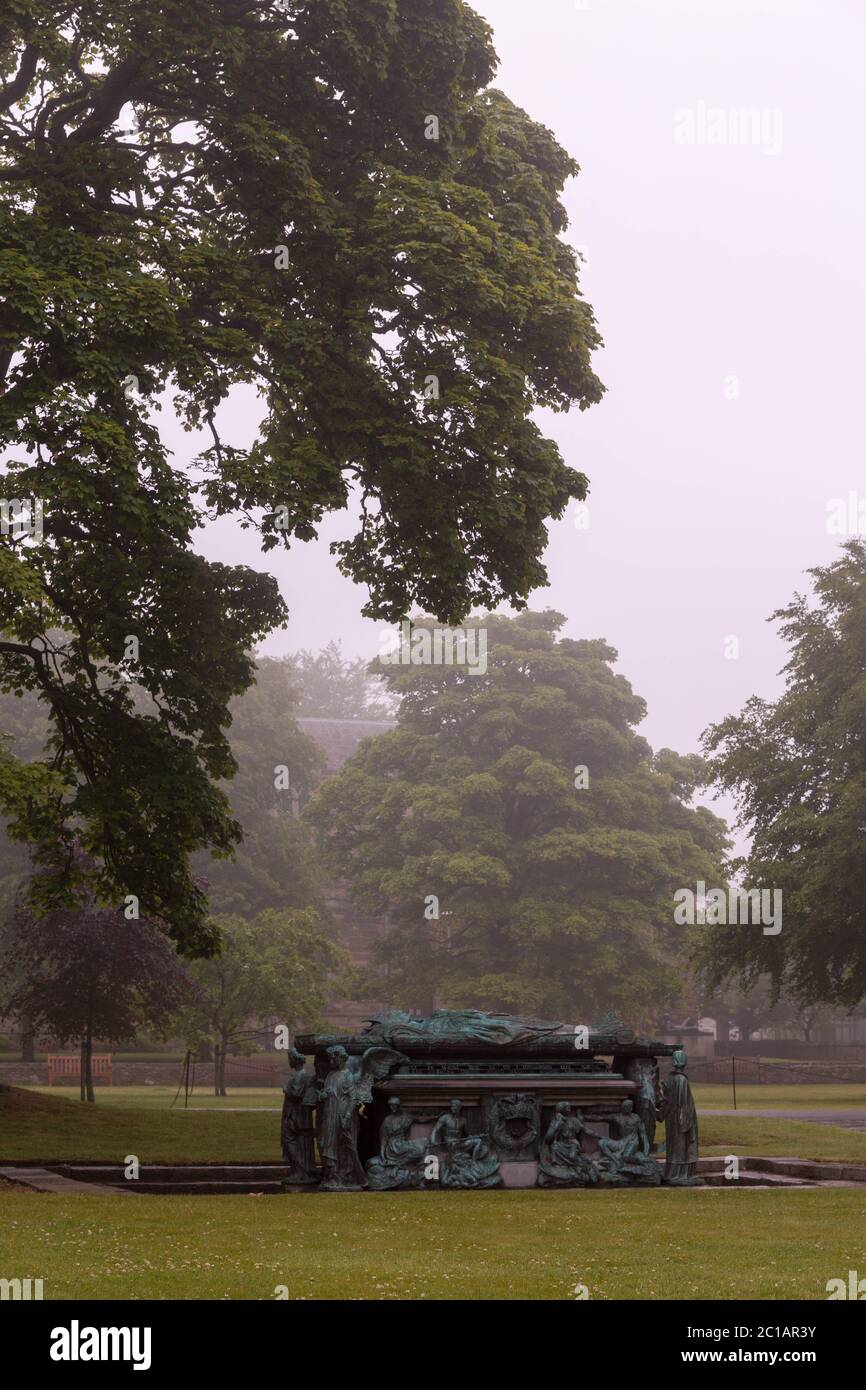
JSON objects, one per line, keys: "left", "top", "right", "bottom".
{"left": 282, "top": 1009, "right": 701, "bottom": 1191}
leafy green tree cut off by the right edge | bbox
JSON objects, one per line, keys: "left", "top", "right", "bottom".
{"left": 698, "top": 538, "right": 866, "bottom": 1008}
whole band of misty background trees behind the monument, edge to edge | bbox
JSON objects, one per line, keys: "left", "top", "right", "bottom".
{"left": 0, "top": 539, "right": 866, "bottom": 1090}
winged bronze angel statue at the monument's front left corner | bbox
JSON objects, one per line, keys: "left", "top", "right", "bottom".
{"left": 318, "top": 1044, "right": 409, "bottom": 1193}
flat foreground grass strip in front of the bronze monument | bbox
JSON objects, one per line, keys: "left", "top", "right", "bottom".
{"left": 0, "top": 1188, "right": 866, "bottom": 1301}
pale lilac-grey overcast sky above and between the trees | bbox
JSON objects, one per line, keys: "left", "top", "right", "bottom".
{"left": 180, "top": 0, "right": 866, "bottom": 828}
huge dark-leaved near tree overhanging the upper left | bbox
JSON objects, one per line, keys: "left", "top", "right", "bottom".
{"left": 0, "top": 0, "right": 602, "bottom": 952}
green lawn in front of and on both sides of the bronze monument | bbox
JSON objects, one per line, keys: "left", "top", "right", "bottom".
{"left": 0, "top": 1088, "right": 866, "bottom": 1300}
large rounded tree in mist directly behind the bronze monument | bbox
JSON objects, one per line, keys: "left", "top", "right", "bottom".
{"left": 309, "top": 612, "right": 724, "bottom": 1023}
